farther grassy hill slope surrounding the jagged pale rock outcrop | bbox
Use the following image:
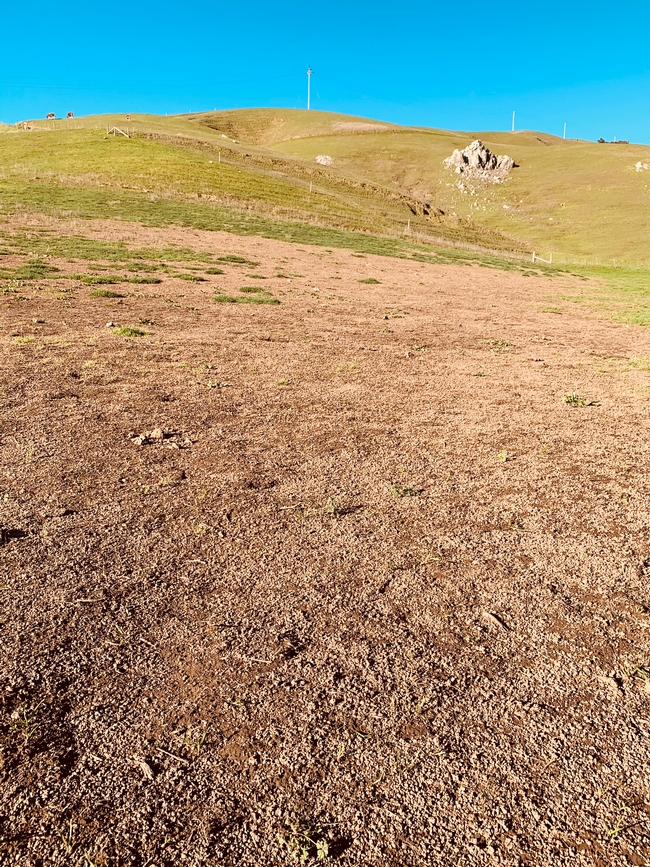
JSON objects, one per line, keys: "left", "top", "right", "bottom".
{"left": 199, "top": 110, "right": 650, "bottom": 263}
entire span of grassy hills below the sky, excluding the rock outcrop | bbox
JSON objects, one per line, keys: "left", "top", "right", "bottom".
{"left": 0, "top": 109, "right": 650, "bottom": 264}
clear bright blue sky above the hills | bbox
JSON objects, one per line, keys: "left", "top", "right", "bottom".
{"left": 0, "top": 0, "right": 650, "bottom": 144}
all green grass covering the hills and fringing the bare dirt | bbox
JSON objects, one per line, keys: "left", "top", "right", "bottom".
{"left": 0, "top": 109, "right": 650, "bottom": 325}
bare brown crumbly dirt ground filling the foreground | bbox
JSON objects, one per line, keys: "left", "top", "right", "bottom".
{"left": 0, "top": 212, "right": 650, "bottom": 867}
